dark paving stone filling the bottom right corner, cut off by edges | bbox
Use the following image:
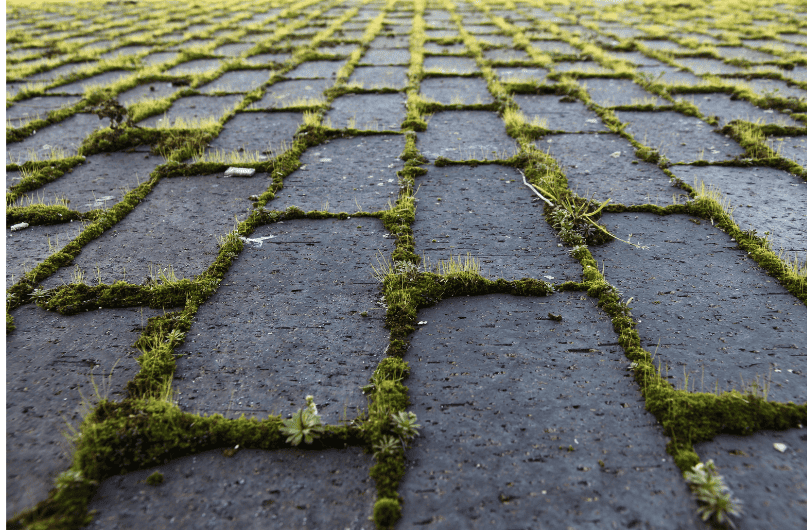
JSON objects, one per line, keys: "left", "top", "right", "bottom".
{"left": 695, "top": 426, "right": 807, "bottom": 530}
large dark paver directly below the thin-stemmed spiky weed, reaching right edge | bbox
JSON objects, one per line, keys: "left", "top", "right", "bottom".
{"left": 590, "top": 213, "right": 807, "bottom": 403}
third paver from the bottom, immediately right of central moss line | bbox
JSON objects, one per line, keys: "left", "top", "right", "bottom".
{"left": 418, "top": 110, "right": 518, "bottom": 160}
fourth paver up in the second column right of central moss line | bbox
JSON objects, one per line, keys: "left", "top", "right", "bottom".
{"left": 513, "top": 94, "right": 608, "bottom": 132}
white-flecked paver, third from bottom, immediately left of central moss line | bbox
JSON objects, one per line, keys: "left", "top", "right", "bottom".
{"left": 266, "top": 135, "right": 404, "bottom": 213}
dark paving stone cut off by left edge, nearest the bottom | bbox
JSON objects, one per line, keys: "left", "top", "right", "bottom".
{"left": 6, "top": 304, "right": 158, "bottom": 517}
